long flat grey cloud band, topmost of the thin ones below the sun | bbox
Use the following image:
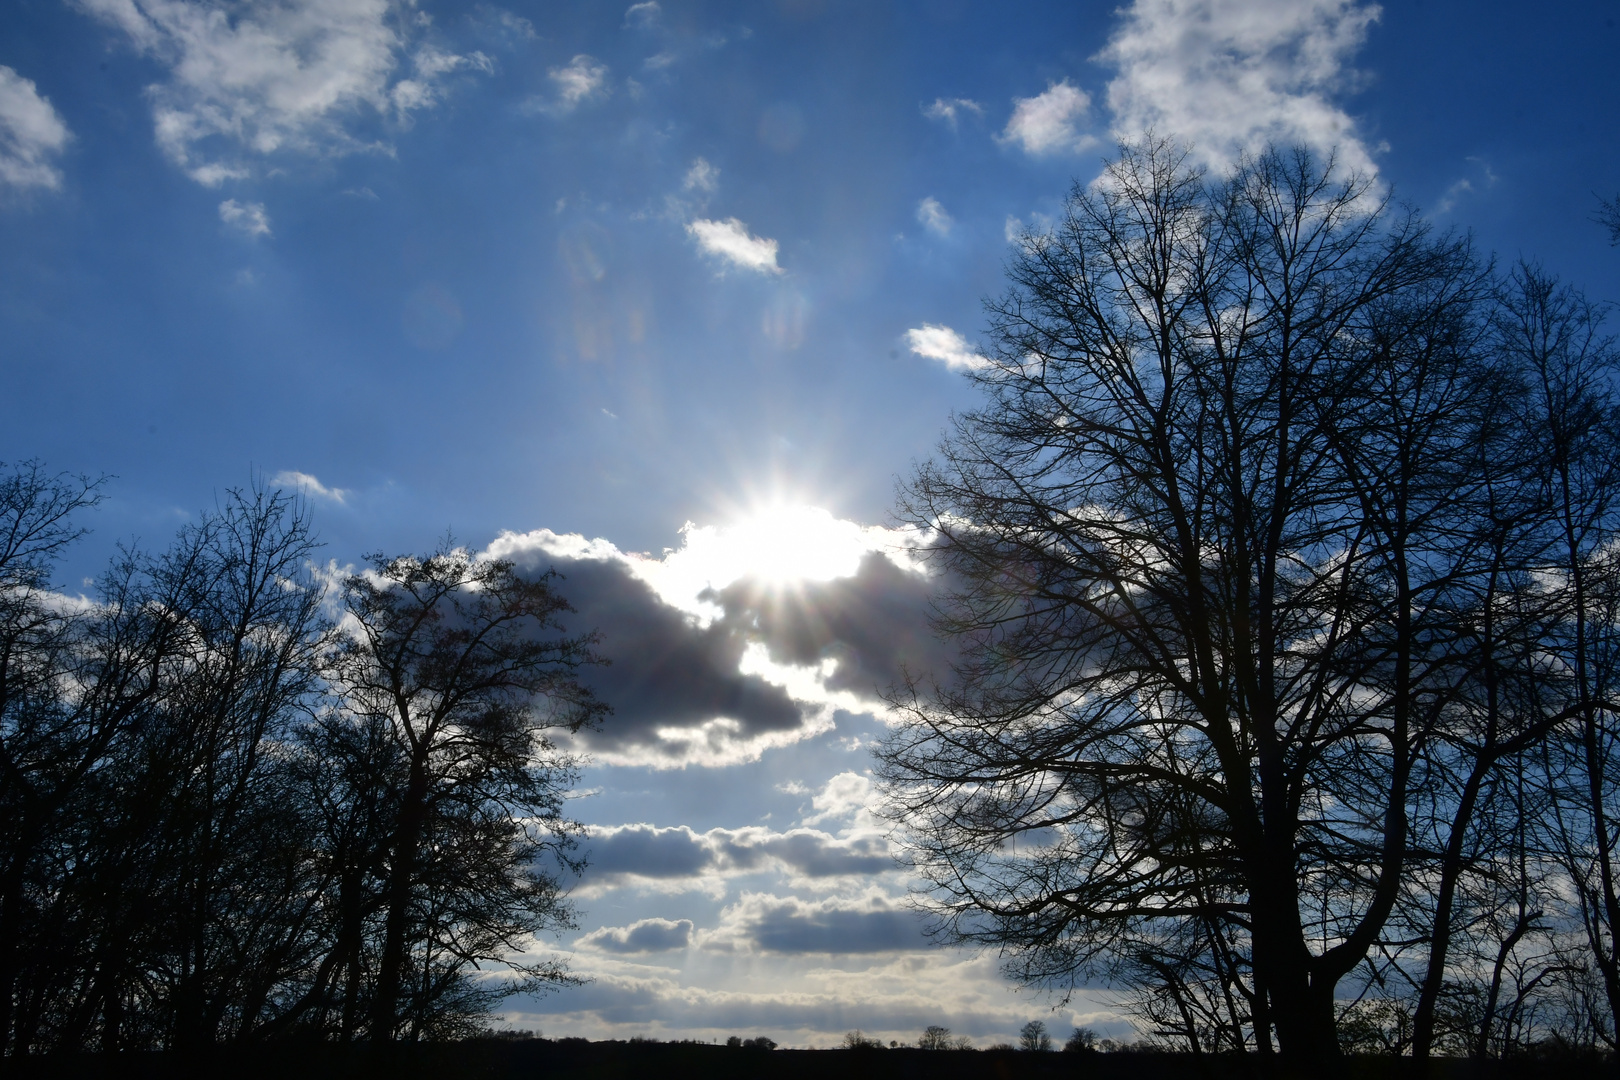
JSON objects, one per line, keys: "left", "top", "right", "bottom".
{"left": 585, "top": 824, "right": 894, "bottom": 884}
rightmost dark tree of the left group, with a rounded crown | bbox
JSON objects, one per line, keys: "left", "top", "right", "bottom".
{"left": 330, "top": 546, "right": 606, "bottom": 1041}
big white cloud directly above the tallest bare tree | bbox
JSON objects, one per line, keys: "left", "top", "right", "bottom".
{"left": 1098, "top": 0, "right": 1379, "bottom": 175}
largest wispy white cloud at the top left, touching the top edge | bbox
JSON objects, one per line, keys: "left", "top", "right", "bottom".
{"left": 78, "top": 0, "right": 492, "bottom": 186}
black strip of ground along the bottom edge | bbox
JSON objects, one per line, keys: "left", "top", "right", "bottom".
{"left": 0, "top": 1040, "right": 1620, "bottom": 1080}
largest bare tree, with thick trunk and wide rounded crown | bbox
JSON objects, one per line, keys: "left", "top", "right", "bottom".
{"left": 881, "top": 141, "right": 1495, "bottom": 1064}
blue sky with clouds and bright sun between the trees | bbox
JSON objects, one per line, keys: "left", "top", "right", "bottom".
{"left": 0, "top": 0, "right": 1620, "bottom": 1046}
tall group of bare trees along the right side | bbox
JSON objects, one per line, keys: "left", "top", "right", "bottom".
{"left": 881, "top": 139, "right": 1620, "bottom": 1070}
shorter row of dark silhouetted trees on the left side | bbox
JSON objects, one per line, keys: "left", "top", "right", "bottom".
{"left": 0, "top": 461, "right": 603, "bottom": 1056}
